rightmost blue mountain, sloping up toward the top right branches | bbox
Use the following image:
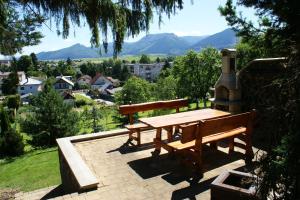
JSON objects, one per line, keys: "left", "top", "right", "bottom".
{"left": 191, "top": 29, "right": 237, "bottom": 51}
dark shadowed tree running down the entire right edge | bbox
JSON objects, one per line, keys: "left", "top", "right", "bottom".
{"left": 219, "top": 0, "right": 300, "bottom": 199}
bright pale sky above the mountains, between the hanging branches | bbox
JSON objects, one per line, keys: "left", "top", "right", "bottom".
{"left": 6, "top": 0, "right": 255, "bottom": 54}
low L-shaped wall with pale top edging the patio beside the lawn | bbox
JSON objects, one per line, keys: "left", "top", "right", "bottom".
{"left": 56, "top": 129, "right": 129, "bottom": 193}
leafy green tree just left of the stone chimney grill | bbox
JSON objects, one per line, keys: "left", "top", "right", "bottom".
{"left": 172, "top": 48, "right": 221, "bottom": 108}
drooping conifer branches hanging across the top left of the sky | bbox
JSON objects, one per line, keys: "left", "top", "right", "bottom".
{"left": 7, "top": 0, "right": 183, "bottom": 54}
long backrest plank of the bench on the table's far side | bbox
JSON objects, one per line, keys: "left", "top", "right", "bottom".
{"left": 119, "top": 99, "right": 188, "bottom": 115}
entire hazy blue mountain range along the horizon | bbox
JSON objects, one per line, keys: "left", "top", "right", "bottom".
{"left": 37, "top": 29, "right": 237, "bottom": 60}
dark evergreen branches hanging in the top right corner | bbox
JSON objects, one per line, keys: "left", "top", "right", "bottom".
{"left": 219, "top": 0, "right": 300, "bottom": 56}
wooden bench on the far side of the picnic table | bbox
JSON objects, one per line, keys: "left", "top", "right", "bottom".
{"left": 119, "top": 99, "right": 188, "bottom": 145}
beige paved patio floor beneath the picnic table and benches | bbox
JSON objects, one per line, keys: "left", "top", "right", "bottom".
{"left": 17, "top": 130, "right": 258, "bottom": 200}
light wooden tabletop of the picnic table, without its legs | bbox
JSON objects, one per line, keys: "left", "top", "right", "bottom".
{"left": 139, "top": 108, "right": 231, "bottom": 128}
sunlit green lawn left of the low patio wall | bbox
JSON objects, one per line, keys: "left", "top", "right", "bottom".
{"left": 0, "top": 148, "right": 61, "bottom": 191}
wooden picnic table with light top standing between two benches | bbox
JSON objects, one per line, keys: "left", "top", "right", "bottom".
{"left": 139, "top": 108, "right": 231, "bottom": 155}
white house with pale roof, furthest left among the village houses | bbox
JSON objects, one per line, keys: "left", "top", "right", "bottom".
{"left": 18, "top": 77, "right": 43, "bottom": 95}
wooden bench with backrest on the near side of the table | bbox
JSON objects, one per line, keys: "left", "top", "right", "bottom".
{"left": 162, "top": 110, "right": 256, "bottom": 173}
